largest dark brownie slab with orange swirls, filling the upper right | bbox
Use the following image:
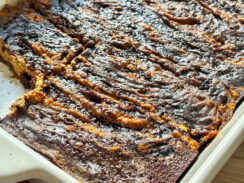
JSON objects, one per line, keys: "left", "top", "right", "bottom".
{"left": 32, "top": 0, "right": 244, "bottom": 136}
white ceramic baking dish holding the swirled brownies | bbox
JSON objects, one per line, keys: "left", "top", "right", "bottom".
{"left": 0, "top": 0, "right": 244, "bottom": 183}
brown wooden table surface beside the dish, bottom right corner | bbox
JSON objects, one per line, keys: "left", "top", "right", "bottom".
{"left": 212, "top": 142, "right": 244, "bottom": 183}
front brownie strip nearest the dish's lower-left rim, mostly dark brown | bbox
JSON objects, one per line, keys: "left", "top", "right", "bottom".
{"left": 2, "top": 97, "right": 197, "bottom": 182}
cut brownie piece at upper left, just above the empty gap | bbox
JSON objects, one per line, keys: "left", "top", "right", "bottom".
{"left": 0, "top": 5, "right": 83, "bottom": 87}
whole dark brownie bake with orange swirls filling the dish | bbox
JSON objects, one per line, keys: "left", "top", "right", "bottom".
{"left": 0, "top": 0, "right": 244, "bottom": 183}
